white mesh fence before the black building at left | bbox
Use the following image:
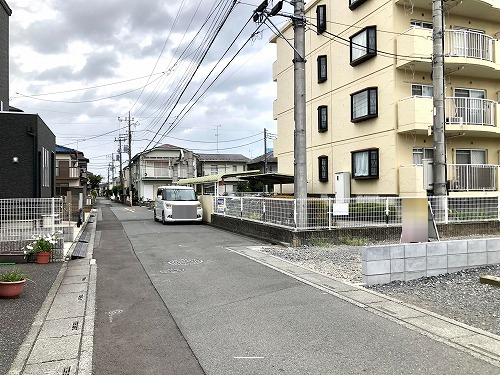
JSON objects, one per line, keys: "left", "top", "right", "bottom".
{"left": 0, "top": 198, "right": 64, "bottom": 241}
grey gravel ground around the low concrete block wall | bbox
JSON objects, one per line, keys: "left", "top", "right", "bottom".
{"left": 262, "top": 245, "right": 500, "bottom": 335}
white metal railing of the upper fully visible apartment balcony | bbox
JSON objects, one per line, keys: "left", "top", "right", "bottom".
{"left": 444, "top": 30, "right": 493, "bottom": 61}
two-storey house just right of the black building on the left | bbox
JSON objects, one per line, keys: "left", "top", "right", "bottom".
{"left": 56, "top": 145, "right": 89, "bottom": 203}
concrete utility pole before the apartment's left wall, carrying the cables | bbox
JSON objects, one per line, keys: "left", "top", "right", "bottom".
{"left": 293, "top": 0, "right": 307, "bottom": 228}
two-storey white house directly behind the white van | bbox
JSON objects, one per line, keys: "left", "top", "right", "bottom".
{"left": 131, "top": 144, "right": 197, "bottom": 203}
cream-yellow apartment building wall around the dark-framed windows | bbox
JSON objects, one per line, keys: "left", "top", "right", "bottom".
{"left": 271, "top": 0, "right": 500, "bottom": 195}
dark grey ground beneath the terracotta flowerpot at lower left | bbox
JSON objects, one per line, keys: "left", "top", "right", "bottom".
{"left": 0, "top": 262, "right": 63, "bottom": 374}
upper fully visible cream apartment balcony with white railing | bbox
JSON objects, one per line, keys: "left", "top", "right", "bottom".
{"left": 396, "top": 27, "right": 500, "bottom": 79}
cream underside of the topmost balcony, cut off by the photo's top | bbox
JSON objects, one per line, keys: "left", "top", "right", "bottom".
{"left": 395, "top": 0, "right": 500, "bottom": 22}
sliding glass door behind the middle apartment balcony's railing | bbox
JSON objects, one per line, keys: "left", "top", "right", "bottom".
{"left": 455, "top": 89, "right": 488, "bottom": 125}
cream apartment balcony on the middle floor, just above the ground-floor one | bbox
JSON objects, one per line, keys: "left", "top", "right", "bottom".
{"left": 397, "top": 96, "right": 500, "bottom": 137}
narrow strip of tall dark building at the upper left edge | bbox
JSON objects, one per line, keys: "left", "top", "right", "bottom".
{"left": 0, "top": 0, "right": 12, "bottom": 111}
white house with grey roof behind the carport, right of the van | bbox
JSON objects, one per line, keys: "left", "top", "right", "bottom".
{"left": 197, "top": 154, "right": 249, "bottom": 194}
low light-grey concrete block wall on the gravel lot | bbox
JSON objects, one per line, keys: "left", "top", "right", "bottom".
{"left": 362, "top": 238, "right": 500, "bottom": 285}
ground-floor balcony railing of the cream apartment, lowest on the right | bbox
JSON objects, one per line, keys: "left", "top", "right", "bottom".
{"left": 447, "top": 164, "right": 498, "bottom": 191}
